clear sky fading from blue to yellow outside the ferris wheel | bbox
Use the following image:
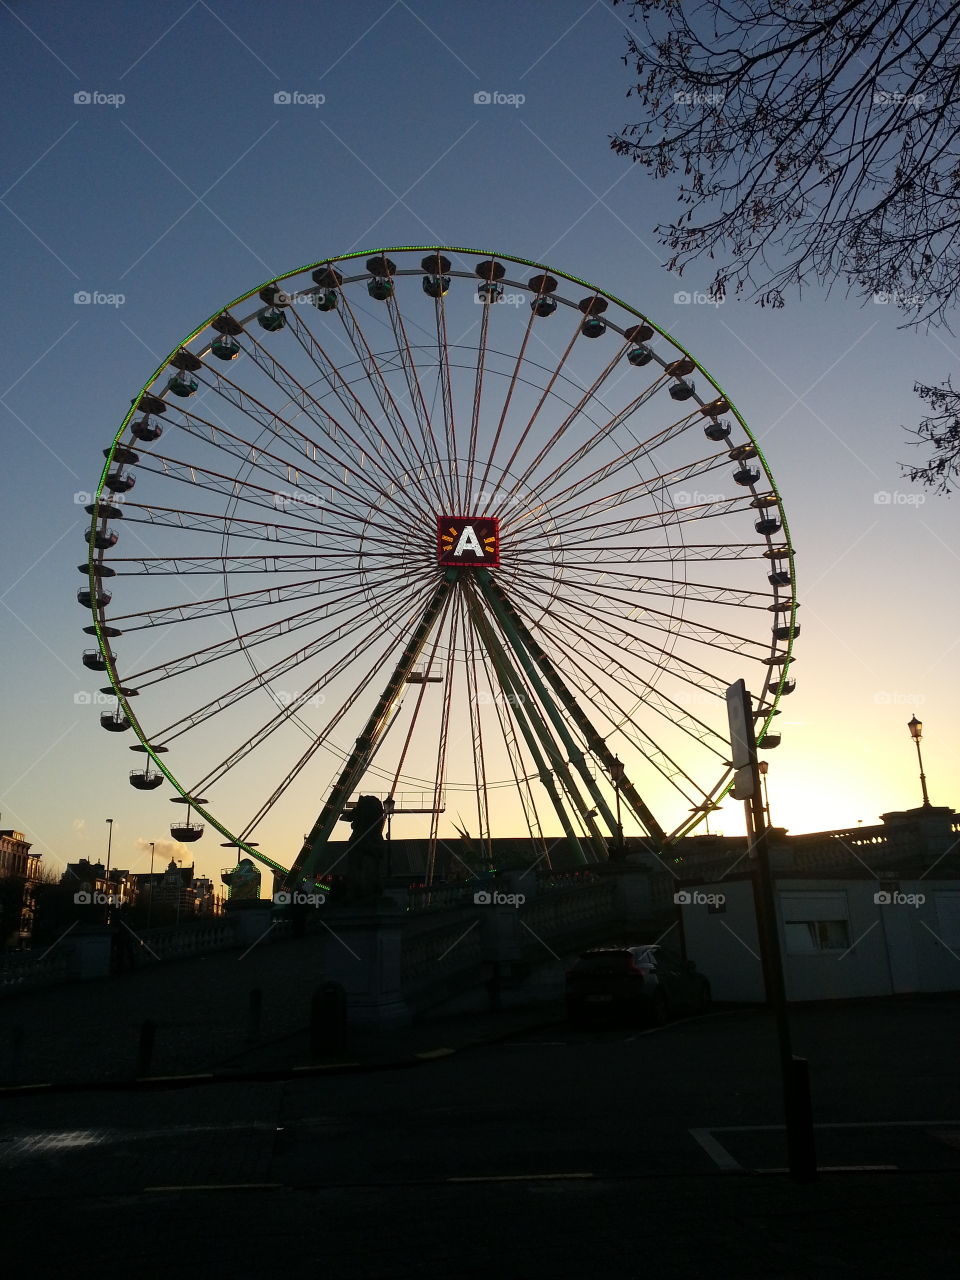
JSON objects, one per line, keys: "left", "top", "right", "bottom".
{"left": 0, "top": 0, "right": 960, "bottom": 874}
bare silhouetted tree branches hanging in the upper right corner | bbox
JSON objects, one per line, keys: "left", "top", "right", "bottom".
{"left": 611, "top": 0, "right": 960, "bottom": 492}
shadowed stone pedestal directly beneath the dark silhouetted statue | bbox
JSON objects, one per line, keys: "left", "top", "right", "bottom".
{"left": 317, "top": 899, "right": 411, "bottom": 1027}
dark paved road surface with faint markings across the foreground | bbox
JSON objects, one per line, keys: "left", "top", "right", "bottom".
{"left": 0, "top": 1000, "right": 960, "bottom": 1280}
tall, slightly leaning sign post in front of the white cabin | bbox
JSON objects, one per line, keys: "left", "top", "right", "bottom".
{"left": 727, "top": 680, "right": 817, "bottom": 1183}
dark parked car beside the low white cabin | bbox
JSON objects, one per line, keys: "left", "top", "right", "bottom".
{"left": 567, "top": 945, "right": 710, "bottom": 1025}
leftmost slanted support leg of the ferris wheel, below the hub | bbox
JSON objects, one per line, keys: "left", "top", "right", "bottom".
{"left": 287, "top": 570, "right": 457, "bottom": 887}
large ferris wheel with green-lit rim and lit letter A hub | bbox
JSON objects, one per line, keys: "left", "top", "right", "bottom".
{"left": 78, "top": 246, "right": 799, "bottom": 878}
